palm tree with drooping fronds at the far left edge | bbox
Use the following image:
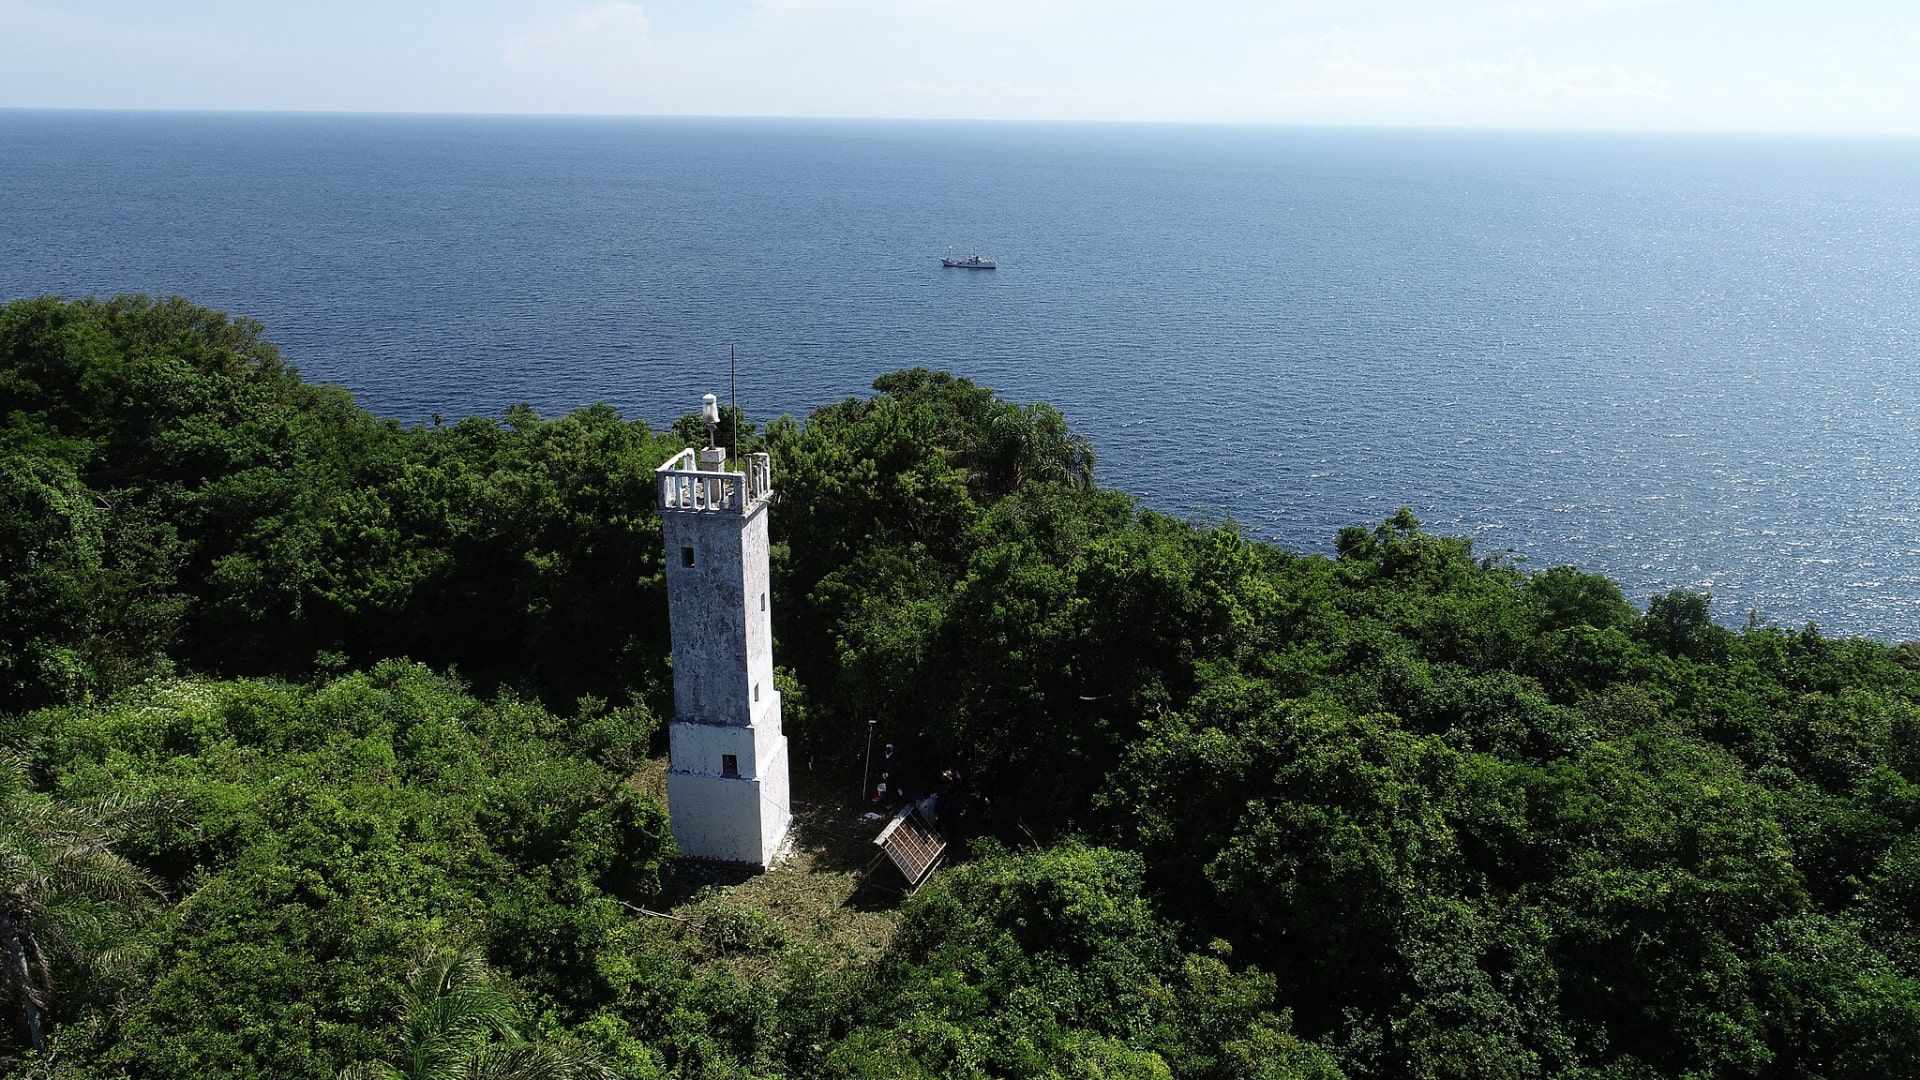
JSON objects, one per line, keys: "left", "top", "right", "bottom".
{"left": 0, "top": 751, "right": 159, "bottom": 1051}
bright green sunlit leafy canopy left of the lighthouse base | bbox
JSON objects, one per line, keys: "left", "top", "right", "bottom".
{"left": 15, "top": 661, "right": 672, "bottom": 1080}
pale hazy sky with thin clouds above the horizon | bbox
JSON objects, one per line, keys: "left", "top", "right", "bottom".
{"left": 11, "top": 0, "right": 1920, "bottom": 135}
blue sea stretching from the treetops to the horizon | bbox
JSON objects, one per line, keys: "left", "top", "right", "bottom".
{"left": 11, "top": 111, "right": 1920, "bottom": 640}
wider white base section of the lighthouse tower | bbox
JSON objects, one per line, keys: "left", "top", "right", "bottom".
{"left": 666, "top": 696, "right": 793, "bottom": 869}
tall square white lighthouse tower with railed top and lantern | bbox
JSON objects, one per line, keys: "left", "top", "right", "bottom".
{"left": 655, "top": 394, "right": 793, "bottom": 869}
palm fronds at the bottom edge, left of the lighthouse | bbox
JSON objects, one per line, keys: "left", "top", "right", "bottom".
{"left": 340, "top": 949, "right": 612, "bottom": 1080}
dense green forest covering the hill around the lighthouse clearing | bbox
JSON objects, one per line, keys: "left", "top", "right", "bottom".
{"left": 0, "top": 298, "right": 1920, "bottom": 1080}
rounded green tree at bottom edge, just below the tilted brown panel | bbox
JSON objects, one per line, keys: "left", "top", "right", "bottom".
{"left": 840, "top": 842, "right": 1340, "bottom": 1080}
